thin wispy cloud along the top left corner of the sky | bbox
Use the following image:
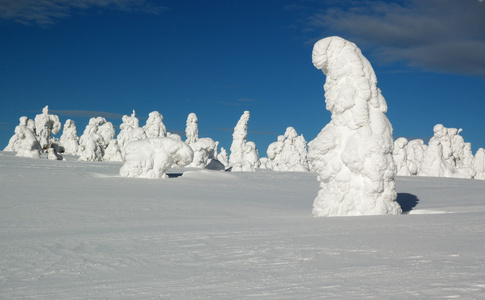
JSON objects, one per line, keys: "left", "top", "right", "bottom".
{"left": 0, "top": 0, "right": 167, "bottom": 26}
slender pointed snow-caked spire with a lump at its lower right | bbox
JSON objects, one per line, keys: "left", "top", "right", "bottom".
{"left": 229, "top": 111, "right": 260, "bottom": 171}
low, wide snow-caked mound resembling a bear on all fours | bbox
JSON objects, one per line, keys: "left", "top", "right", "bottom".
{"left": 120, "top": 137, "right": 194, "bottom": 179}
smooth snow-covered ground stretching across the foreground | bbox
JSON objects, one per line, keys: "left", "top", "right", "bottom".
{"left": 0, "top": 152, "right": 485, "bottom": 299}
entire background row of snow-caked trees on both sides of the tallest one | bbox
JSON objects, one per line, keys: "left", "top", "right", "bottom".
{"left": 4, "top": 106, "right": 485, "bottom": 179}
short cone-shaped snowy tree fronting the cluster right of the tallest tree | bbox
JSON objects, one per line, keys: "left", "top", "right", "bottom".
{"left": 418, "top": 138, "right": 455, "bottom": 177}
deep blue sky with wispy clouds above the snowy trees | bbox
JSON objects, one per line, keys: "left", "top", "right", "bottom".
{"left": 0, "top": 0, "right": 485, "bottom": 157}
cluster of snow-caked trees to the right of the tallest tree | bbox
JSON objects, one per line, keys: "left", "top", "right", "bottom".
{"left": 392, "top": 124, "right": 485, "bottom": 180}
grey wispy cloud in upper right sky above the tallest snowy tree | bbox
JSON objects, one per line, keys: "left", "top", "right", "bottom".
{"left": 302, "top": 0, "right": 485, "bottom": 77}
